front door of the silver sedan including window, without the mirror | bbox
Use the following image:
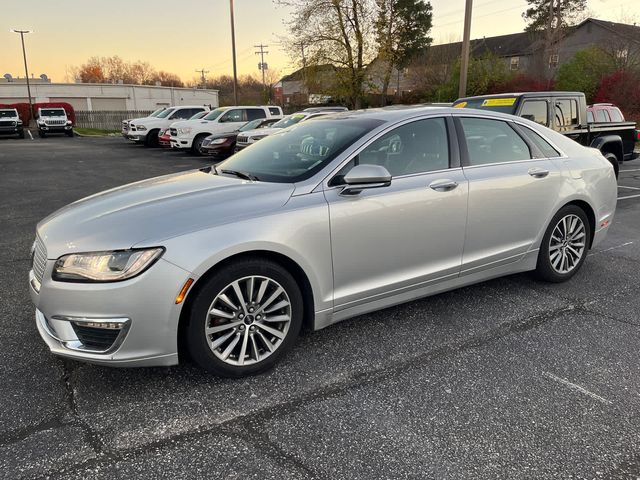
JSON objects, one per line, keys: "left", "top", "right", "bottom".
{"left": 325, "top": 117, "right": 467, "bottom": 311}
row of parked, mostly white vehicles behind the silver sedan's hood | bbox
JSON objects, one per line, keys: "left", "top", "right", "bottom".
{"left": 122, "top": 105, "right": 347, "bottom": 159}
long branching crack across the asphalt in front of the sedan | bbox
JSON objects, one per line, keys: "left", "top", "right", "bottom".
{"left": 35, "top": 305, "right": 576, "bottom": 478}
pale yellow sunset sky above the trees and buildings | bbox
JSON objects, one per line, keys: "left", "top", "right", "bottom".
{"left": 0, "top": 0, "right": 640, "bottom": 82}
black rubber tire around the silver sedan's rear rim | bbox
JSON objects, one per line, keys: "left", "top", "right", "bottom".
{"left": 535, "top": 205, "right": 591, "bottom": 283}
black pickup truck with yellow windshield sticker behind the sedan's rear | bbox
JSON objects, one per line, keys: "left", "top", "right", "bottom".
{"left": 453, "top": 92, "right": 638, "bottom": 177}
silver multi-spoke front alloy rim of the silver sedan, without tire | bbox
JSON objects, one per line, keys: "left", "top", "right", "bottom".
{"left": 205, "top": 276, "right": 291, "bottom": 366}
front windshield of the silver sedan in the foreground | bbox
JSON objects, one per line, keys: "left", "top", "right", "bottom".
{"left": 218, "top": 118, "right": 383, "bottom": 183}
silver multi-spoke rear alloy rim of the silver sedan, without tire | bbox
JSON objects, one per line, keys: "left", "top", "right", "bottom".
{"left": 549, "top": 214, "right": 587, "bottom": 274}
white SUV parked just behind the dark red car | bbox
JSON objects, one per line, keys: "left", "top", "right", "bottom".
{"left": 170, "top": 105, "right": 282, "bottom": 155}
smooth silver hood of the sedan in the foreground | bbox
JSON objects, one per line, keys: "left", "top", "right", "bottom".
{"left": 37, "top": 169, "right": 294, "bottom": 259}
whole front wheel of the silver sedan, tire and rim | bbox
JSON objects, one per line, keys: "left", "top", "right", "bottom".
{"left": 186, "top": 258, "right": 303, "bottom": 377}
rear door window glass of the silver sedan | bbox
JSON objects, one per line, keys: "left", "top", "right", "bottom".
{"left": 460, "top": 118, "right": 531, "bottom": 165}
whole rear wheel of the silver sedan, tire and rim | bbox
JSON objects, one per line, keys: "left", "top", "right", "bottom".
{"left": 536, "top": 205, "right": 591, "bottom": 283}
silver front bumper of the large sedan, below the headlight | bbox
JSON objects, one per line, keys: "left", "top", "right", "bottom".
{"left": 29, "top": 259, "right": 189, "bottom": 367}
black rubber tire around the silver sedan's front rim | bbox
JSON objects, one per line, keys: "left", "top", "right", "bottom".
{"left": 185, "top": 258, "right": 304, "bottom": 377}
